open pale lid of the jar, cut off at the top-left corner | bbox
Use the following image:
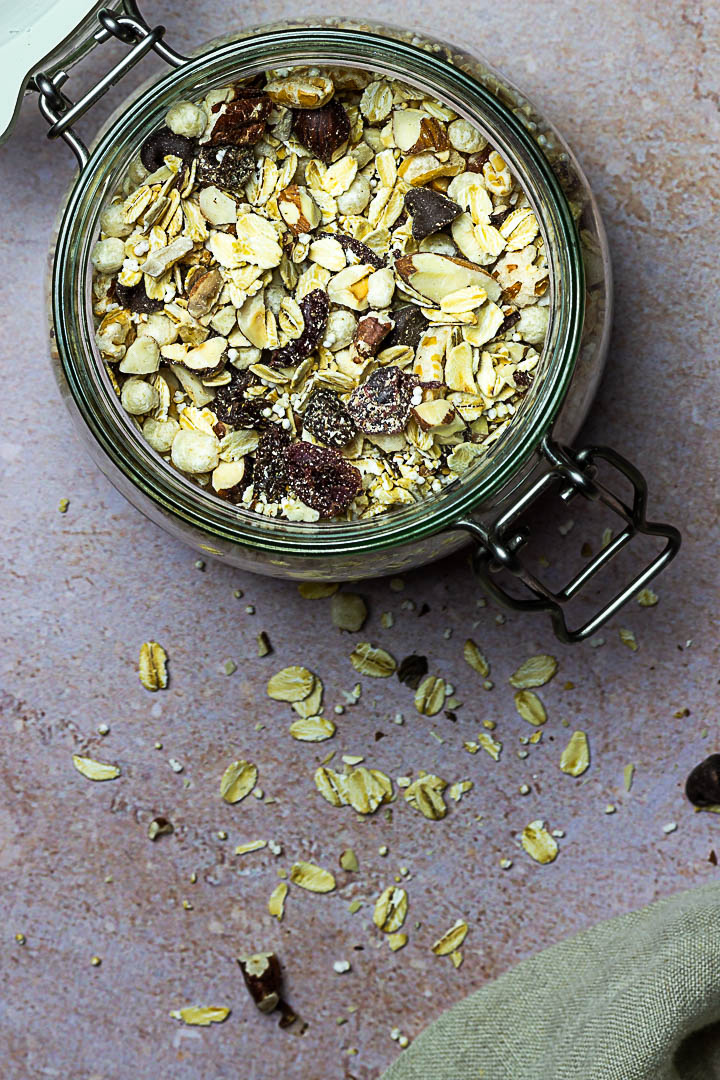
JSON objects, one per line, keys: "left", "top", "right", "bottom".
{"left": 0, "top": 0, "right": 122, "bottom": 143}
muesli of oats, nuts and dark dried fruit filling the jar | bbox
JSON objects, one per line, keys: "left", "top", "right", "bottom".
{"left": 92, "top": 68, "right": 549, "bottom": 522}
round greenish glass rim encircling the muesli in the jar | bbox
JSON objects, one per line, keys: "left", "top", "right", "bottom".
{"left": 52, "top": 21, "right": 584, "bottom": 558}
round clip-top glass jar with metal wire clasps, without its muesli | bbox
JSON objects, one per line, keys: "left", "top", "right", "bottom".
{"left": 19, "top": 0, "right": 680, "bottom": 640}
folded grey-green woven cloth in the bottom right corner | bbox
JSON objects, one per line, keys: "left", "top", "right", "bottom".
{"left": 382, "top": 885, "right": 720, "bottom": 1080}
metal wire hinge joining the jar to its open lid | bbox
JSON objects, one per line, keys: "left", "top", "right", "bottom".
{"left": 31, "top": 0, "right": 188, "bottom": 168}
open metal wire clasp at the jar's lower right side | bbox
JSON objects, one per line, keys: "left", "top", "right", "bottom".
{"left": 458, "top": 437, "right": 681, "bottom": 643}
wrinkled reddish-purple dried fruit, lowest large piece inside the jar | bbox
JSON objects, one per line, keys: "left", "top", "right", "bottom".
{"left": 287, "top": 443, "right": 363, "bottom": 517}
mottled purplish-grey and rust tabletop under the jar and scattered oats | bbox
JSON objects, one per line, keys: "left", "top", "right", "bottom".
{"left": 0, "top": 0, "right": 720, "bottom": 1080}
